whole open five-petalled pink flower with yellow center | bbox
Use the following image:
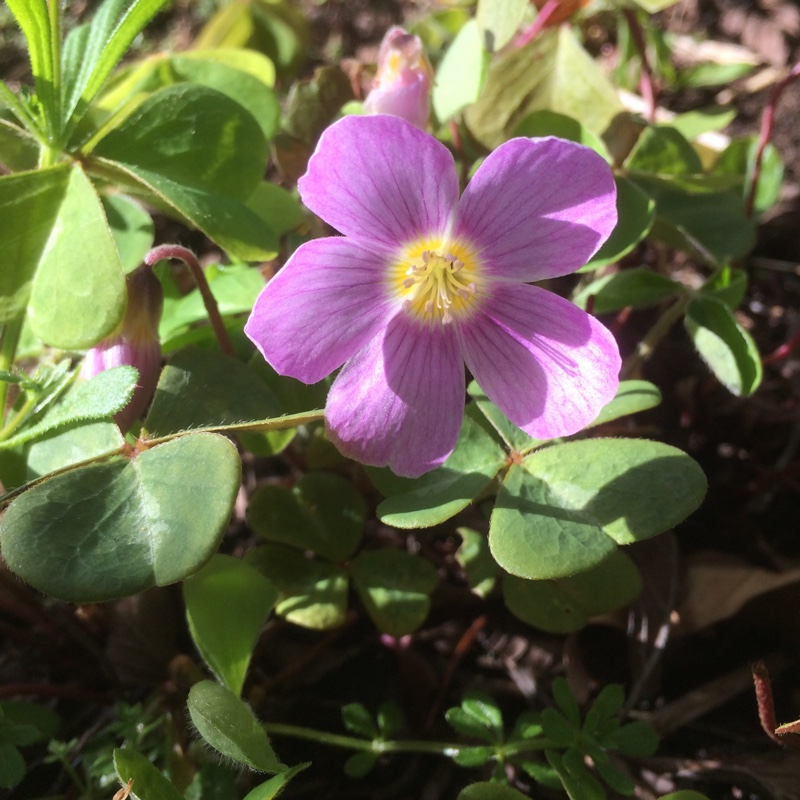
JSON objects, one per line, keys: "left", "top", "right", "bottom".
{"left": 245, "top": 116, "right": 620, "bottom": 477}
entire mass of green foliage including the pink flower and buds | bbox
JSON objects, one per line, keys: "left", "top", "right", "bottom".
{"left": 0, "top": 0, "right": 797, "bottom": 800}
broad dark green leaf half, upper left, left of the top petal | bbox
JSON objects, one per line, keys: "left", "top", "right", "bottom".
{"left": 93, "top": 84, "right": 267, "bottom": 201}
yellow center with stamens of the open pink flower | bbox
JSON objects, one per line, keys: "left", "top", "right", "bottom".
{"left": 393, "top": 242, "right": 481, "bottom": 324}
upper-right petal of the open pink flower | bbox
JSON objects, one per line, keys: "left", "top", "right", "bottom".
{"left": 455, "top": 137, "right": 617, "bottom": 281}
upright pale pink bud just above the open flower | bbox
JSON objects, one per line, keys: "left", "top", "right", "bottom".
{"left": 364, "top": 27, "right": 433, "bottom": 130}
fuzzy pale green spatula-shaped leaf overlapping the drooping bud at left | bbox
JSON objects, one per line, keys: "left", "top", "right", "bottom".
{"left": 0, "top": 366, "right": 139, "bottom": 449}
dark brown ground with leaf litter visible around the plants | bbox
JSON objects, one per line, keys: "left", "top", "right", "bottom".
{"left": 0, "top": 0, "right": 800, "bottom": 800}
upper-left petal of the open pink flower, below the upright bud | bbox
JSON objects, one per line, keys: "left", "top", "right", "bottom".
{"left": 298, "top": 114, "right": 458, "bottom": 252}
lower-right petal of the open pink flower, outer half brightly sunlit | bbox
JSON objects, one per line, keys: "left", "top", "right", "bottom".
{"left": 459, "top": 284, "right": 620, "bottom": 439}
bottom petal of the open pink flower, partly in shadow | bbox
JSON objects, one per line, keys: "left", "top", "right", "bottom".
{"left": 326, "top": 314, "right": 464, "bottom": 478}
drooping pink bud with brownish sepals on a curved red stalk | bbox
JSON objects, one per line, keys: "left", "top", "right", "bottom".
{"left": 80, "top": 267, "right": 164, "bottom": 433}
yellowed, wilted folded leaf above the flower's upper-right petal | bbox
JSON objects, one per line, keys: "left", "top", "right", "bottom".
{"left": 464, "top": 25, "right": 623, "bottom": 148}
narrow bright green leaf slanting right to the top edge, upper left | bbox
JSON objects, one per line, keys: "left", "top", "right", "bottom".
{"left": 63, "top": 0, "right": 167, "bottom": 138}
